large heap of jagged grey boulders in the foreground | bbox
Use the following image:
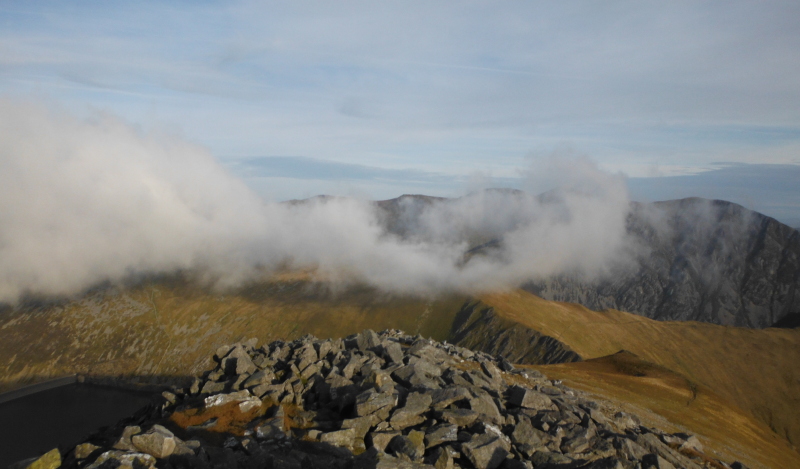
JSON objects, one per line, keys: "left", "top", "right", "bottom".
{"left": 51, "top": 330, "right": 743, "bottom": 469}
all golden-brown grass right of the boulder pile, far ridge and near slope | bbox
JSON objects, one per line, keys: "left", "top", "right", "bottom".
{"left": 481, "top": 291, "right": 800, "bottom": 467}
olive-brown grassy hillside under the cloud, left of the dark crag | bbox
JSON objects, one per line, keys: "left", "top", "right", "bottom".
{"left": 0, "top": 279, "right": 464, "bottom": 391}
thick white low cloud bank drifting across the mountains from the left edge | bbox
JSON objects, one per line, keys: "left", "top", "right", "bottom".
{"left": 0, "top": 100, "right": 629, "bottom": 302}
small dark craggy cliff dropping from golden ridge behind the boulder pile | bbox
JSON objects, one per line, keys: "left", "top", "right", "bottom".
{"left": 449, "top": 301, "right": 581, "bottom": 365}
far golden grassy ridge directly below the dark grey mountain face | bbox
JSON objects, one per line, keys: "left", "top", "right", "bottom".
{"left": 481, "top": 291, "right": 800, "bottom": 467}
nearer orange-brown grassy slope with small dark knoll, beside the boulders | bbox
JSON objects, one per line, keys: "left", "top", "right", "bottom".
{"left": 535, "top": 352, "right": 800, "bottom": 468}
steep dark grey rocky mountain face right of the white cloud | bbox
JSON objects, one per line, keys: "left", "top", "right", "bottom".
{"left": 525, "top": 198, "right": 800, "bottom": 328}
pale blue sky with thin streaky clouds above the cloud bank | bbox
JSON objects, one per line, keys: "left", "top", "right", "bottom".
{"left": 0, "top": 0, "right": 800, "bottom": 226}
